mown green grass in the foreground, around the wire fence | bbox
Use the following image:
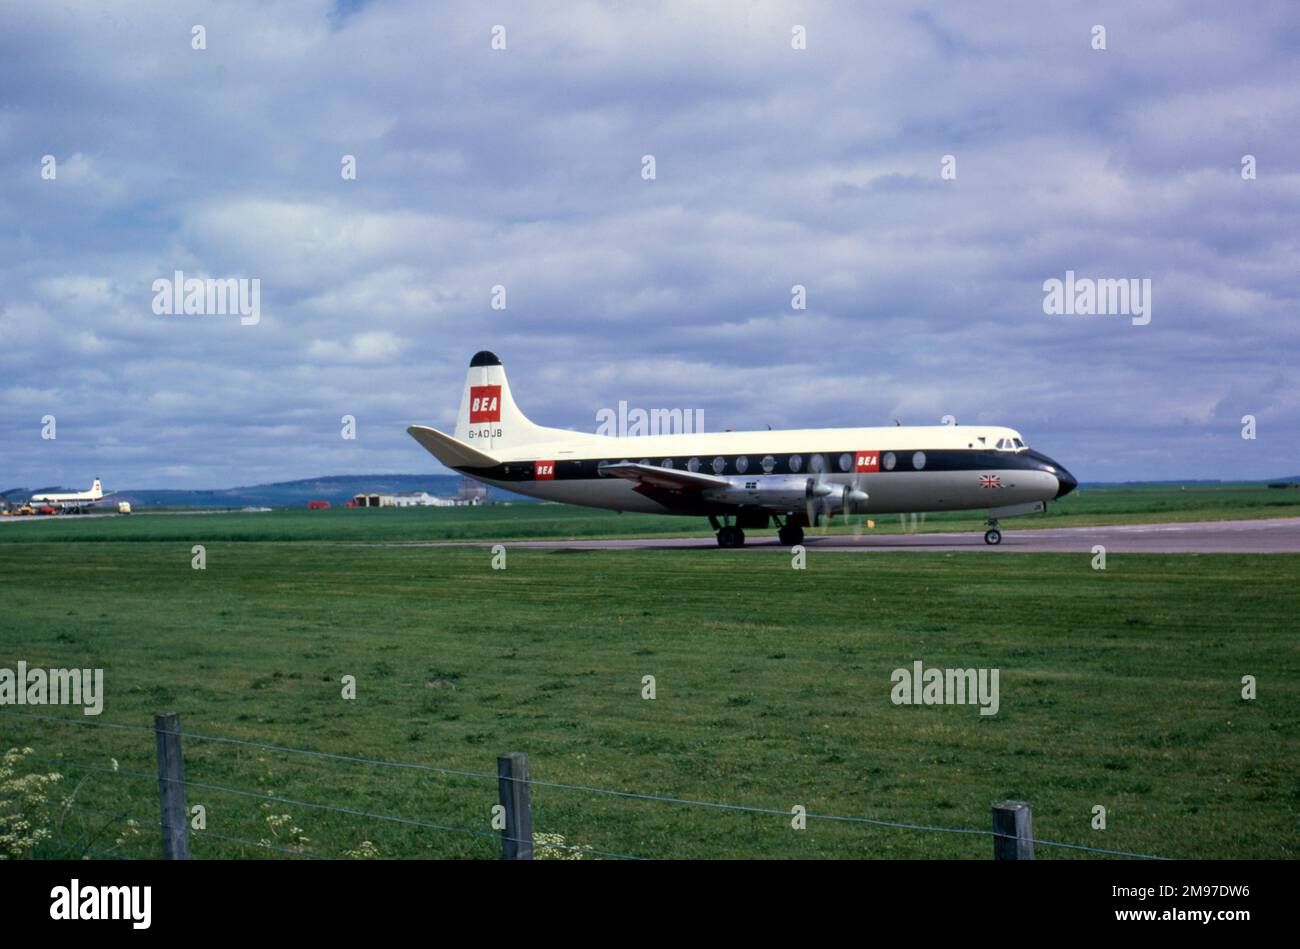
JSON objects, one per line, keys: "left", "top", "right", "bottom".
{"left": 0, "top": 509, "right": 1300, "bottom": 859}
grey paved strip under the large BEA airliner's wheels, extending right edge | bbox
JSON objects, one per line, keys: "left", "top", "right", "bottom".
{"left": 397, "top": 517, "right": 1300, "bottom": 554}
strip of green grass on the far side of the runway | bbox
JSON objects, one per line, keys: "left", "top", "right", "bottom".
{"left": 0, "top": 485, "right": 1300, "bottom": 545}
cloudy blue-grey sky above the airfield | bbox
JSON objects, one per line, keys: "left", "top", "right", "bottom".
{"left": 0, "top": 0, "right": 1300, "bottom": 489}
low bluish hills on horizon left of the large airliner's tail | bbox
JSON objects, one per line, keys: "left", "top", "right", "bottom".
{"left": 0, "top": 475, "right": 532, "bottom": 508}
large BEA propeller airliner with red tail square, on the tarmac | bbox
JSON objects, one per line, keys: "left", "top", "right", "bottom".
{"left": 407, "top": 351, "right": 1078, "bottom": 547}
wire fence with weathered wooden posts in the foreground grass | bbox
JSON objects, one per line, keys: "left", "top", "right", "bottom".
{"left": 0, "top": 709, "right": 1169, "bottom": 861}
